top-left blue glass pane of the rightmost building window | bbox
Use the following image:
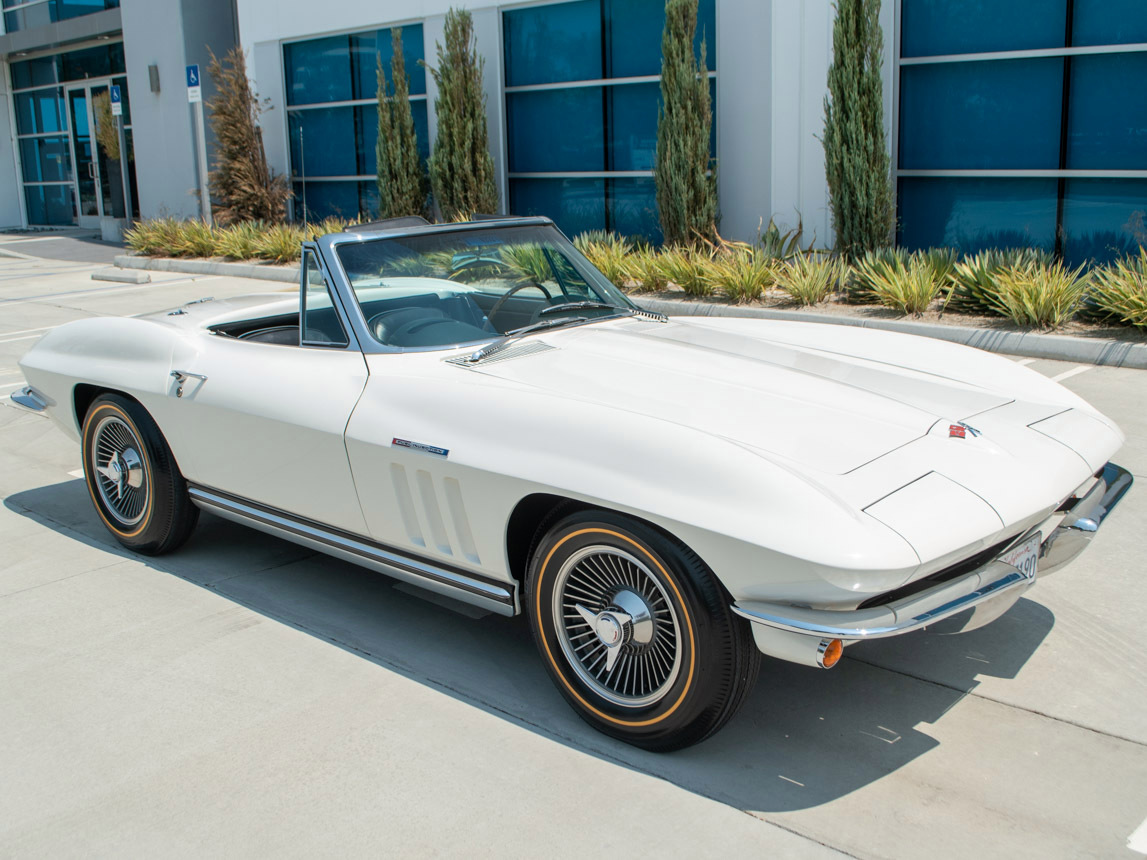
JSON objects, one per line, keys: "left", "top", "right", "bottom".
{"left": 900, "top": 0, "right": 1067, "bottom": 56}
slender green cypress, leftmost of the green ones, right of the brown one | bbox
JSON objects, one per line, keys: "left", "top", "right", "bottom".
{"left": 375, "top": 28, "right": 427, "bottom": 218}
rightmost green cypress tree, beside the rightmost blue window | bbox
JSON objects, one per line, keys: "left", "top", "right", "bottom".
{"left": 822, "top": 0, "right": 892, "bottom": 258}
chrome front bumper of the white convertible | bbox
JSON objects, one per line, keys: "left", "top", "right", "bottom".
{"left": 732, "top": 463, "right": 1132, "bottom": 656}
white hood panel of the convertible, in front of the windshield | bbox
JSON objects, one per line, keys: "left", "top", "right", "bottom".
{"left": 465, "top": 321, "right": 1013, "bottom": 475}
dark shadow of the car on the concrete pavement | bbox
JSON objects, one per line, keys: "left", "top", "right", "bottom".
{"left": 5, "top": 480, "right": 1054, "bottom": 812}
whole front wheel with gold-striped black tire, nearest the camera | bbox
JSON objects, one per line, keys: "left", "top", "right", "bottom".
{"left": 525, "top": 510, "right": 760, "bottom": 751}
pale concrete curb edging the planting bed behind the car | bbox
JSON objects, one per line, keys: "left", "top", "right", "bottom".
{"left": 115, "top": 255, "right": 1147, "bottom": 370}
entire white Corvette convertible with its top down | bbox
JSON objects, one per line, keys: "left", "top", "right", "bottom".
{"left": 14, "top": 218, "right": 1131, "bottom": 750}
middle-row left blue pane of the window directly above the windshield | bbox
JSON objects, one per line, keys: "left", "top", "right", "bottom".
{"left": 506, "top": 89, "right": 605, "bottom": 173}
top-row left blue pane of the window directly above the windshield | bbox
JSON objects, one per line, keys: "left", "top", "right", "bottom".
{"left": 502, "top": 0, "right": 604, "bottom": 86}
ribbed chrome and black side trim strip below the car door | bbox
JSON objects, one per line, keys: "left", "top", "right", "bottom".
{"left": 187, "top": 485, "right": 517, "bottom": 616}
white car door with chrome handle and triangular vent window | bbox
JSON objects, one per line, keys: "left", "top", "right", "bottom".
{"left": 172, "top": 248, "right": 367, "bottom": 534}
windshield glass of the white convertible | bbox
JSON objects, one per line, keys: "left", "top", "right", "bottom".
{"left": 336, "top": 226, "right": 633, "bottom": 347}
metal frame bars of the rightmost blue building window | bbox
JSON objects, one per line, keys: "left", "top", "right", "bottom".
{"left": 891, "top": 0, "right": 1147, "bottom": 251}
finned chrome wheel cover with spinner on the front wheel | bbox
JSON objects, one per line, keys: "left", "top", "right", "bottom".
{"left": 552, "top": 546, "right": 681, "bottom": 707}
